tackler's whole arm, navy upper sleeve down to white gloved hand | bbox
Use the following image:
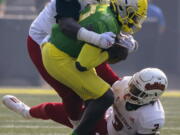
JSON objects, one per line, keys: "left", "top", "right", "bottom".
{"left": 56, "top": 0, "right": 115, "bottom": 48}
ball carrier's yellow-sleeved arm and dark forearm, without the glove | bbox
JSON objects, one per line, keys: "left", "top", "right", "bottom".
{"left": 76, "top": 40, "right": 128, "bottom": 71}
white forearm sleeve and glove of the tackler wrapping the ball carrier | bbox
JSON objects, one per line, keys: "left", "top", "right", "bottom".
{"left": 77, "top": 27, "right": 116, "bottom": 49}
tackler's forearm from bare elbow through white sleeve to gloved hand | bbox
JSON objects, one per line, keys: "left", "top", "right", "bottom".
{"left": 58, "top": 17, "right": 115, "bottom": 49}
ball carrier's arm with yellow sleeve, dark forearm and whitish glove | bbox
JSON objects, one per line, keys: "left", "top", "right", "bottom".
{"left": 76, "top": 33, "right": 138, "bottom": 71}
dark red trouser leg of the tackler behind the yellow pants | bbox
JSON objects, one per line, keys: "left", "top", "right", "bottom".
{"left": 27, "top": 36, "right": 82, "bottom": 121}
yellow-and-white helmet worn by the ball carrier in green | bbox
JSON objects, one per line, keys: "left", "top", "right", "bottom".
{"left": 110, "top": 0, "right": 148, "bottom": 34}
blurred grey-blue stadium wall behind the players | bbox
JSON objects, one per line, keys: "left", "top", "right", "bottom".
{"left": 0, "top": 0, "right": 180, "bottom": 89}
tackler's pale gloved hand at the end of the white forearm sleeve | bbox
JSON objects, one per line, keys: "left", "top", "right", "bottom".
{"left": 99, "top": 32, "right": 116, "bottom": 49}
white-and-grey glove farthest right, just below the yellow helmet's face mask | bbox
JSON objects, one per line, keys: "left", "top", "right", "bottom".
{"left": 118, "top": 33, "right": 139, "bottom": 53}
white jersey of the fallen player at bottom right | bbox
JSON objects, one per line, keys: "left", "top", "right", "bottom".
{"left": 106, "top": 76, "right": 165, "bottom": 135}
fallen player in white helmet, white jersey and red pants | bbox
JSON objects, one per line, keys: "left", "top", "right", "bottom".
{"left": 3, "top": 68, "right": 168, "bottom": 135}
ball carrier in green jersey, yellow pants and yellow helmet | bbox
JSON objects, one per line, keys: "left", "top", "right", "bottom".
{"left": 42, "top": 0, "right": 147, "bottom": 135}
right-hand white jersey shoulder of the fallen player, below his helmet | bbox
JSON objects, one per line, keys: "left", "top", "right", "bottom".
{"left": 138, "top": 100, "right": 165, "bottom": 129}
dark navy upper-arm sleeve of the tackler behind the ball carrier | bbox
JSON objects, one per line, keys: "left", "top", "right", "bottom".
{"left": 55, "top": 0, "right": 81, "bottom": 20}
